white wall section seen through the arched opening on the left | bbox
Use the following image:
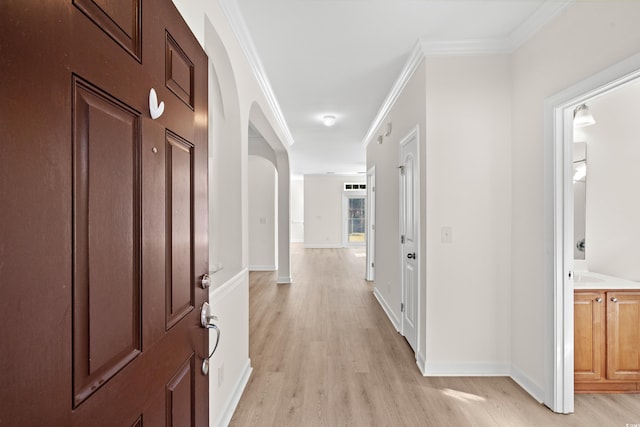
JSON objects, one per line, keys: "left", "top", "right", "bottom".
{"left": 248, "top": 156, "right": 278, "bottom": 271}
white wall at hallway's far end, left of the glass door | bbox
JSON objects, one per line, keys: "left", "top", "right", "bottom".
{"left": 304, "top": 175, "right": 366, "bottom": 248}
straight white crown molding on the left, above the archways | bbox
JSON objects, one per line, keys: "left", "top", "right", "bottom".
{"left": 218, "top": 0, "right": 295, "bottom": 147}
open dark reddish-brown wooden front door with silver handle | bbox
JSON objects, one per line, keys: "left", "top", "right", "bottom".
{"left": 0, "top": 0, "right": 209, "bottom": 427}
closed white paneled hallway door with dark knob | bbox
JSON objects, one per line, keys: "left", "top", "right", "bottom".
{"left": 400, "top": 132, "right": 419, "bottom": 352}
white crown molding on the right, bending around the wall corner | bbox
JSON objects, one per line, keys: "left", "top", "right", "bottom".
{"left": 362, "top": 0, "right": 575, "bottom": 148}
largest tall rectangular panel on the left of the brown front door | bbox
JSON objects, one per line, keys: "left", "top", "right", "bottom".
{"left": 72, "top": 77, "right": 142, "bottom": 406}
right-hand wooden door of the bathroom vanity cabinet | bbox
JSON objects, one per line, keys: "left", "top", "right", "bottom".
{"left": 607, "top": 291, "right": 640, "bottom": 380}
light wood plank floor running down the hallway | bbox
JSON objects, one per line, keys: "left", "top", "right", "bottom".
{"left": 230, "top": 245, "right": 640, "bottom": 427}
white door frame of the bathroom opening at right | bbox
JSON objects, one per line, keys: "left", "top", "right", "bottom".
{"left": 544, "top": 50, "right": 640, "bottom": 414}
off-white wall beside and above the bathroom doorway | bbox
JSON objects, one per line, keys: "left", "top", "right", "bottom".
{"left": 511, "top": 1, "right": 640, "bottom": 400}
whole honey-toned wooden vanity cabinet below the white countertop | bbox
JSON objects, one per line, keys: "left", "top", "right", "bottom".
{"left": 574, "top": 290, "right": 640, "bottom": 393}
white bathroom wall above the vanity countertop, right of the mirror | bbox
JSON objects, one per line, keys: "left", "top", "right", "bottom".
{"left": 583, "top": 82, "right": 640, "bottom": 281}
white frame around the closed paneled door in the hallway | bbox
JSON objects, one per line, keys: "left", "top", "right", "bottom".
{"left": 397, "top": 125, "right": 423, "bottom": 360}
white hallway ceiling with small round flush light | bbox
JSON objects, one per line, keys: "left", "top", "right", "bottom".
{"left": 235, "top": 0, "right": 569, "bottom": 174}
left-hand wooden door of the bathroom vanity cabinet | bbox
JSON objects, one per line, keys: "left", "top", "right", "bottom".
{"left": 573, "top": 291, "right": 605, "bottom": 382}
